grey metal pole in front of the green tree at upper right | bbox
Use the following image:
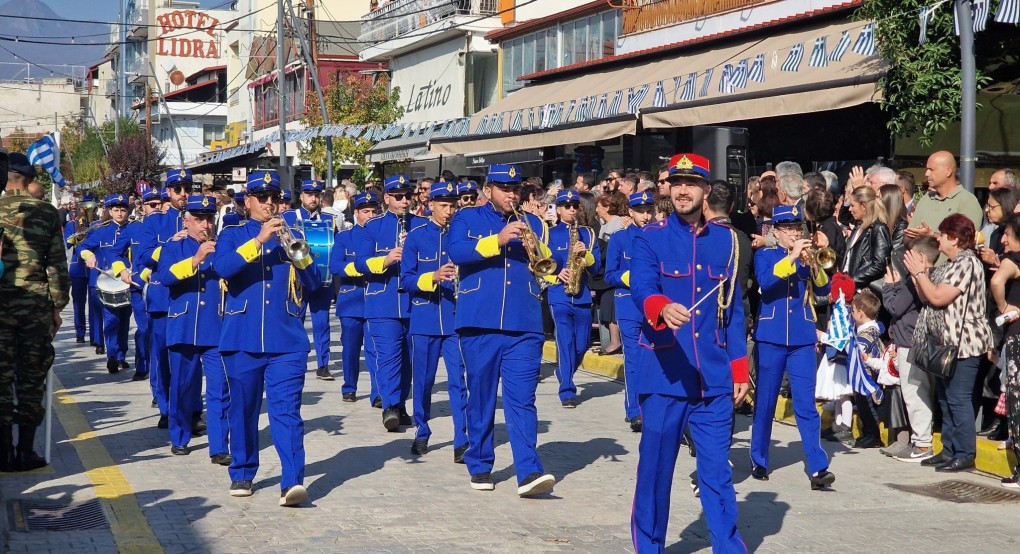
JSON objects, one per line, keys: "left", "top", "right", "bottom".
{"left": 955, "top": 0, "right": 977, "bottom": 193}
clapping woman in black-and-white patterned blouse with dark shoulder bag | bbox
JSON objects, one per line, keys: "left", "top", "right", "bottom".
{"left": 904, "top": 213, "right": 991, "bottom": 471}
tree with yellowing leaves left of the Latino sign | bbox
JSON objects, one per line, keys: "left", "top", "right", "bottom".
{"left": 301, "top": 73, "right": 404, "bottom": 186}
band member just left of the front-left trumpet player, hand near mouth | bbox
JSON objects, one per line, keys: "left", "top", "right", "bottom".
{"left": 155, "top": 195, "right": 232, "bottom": 465}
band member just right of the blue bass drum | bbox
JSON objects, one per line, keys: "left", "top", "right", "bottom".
{"left": 329, "top": 192, "right": 383, "bottom": 408}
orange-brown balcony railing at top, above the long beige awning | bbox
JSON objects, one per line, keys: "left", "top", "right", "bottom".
{"left": 623, "top": 0, "right": 775, "bottom": 35}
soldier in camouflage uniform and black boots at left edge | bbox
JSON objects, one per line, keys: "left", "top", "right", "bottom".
{"left": 0, "top": 153, "right": 70, "bottom": 471}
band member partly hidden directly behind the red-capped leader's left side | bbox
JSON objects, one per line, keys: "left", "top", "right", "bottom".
{"left": 606, "top": 191, "right": 655, "bottom": 433}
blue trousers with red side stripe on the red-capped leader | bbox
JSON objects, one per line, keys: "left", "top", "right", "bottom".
{"left": 630, "top": 394, "right": 748, "bottom": 554}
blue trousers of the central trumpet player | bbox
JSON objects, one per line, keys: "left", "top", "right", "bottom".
{"left": 460, "top": 329, "right": 545, "bottom": 485}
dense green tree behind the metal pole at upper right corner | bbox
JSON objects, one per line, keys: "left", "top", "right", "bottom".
{"left": 855, "top": 0, "right": 1020, "bottom": 145}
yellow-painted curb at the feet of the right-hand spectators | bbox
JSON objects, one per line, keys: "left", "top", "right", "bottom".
{"left": 542, "top": 341, "right": 1016, "bottom": 477}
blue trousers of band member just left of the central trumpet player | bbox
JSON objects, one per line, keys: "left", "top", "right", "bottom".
{"left": 411, "top": 335, "right": 467, "bottom": 448}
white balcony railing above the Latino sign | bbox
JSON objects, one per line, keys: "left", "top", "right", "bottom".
{"left": 358, "top": 0, "right": 499, "bottom": 43}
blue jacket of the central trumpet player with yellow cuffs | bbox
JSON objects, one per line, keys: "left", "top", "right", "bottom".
{"left": 450, "top": 203, "right": 550, "bottom": 333}
